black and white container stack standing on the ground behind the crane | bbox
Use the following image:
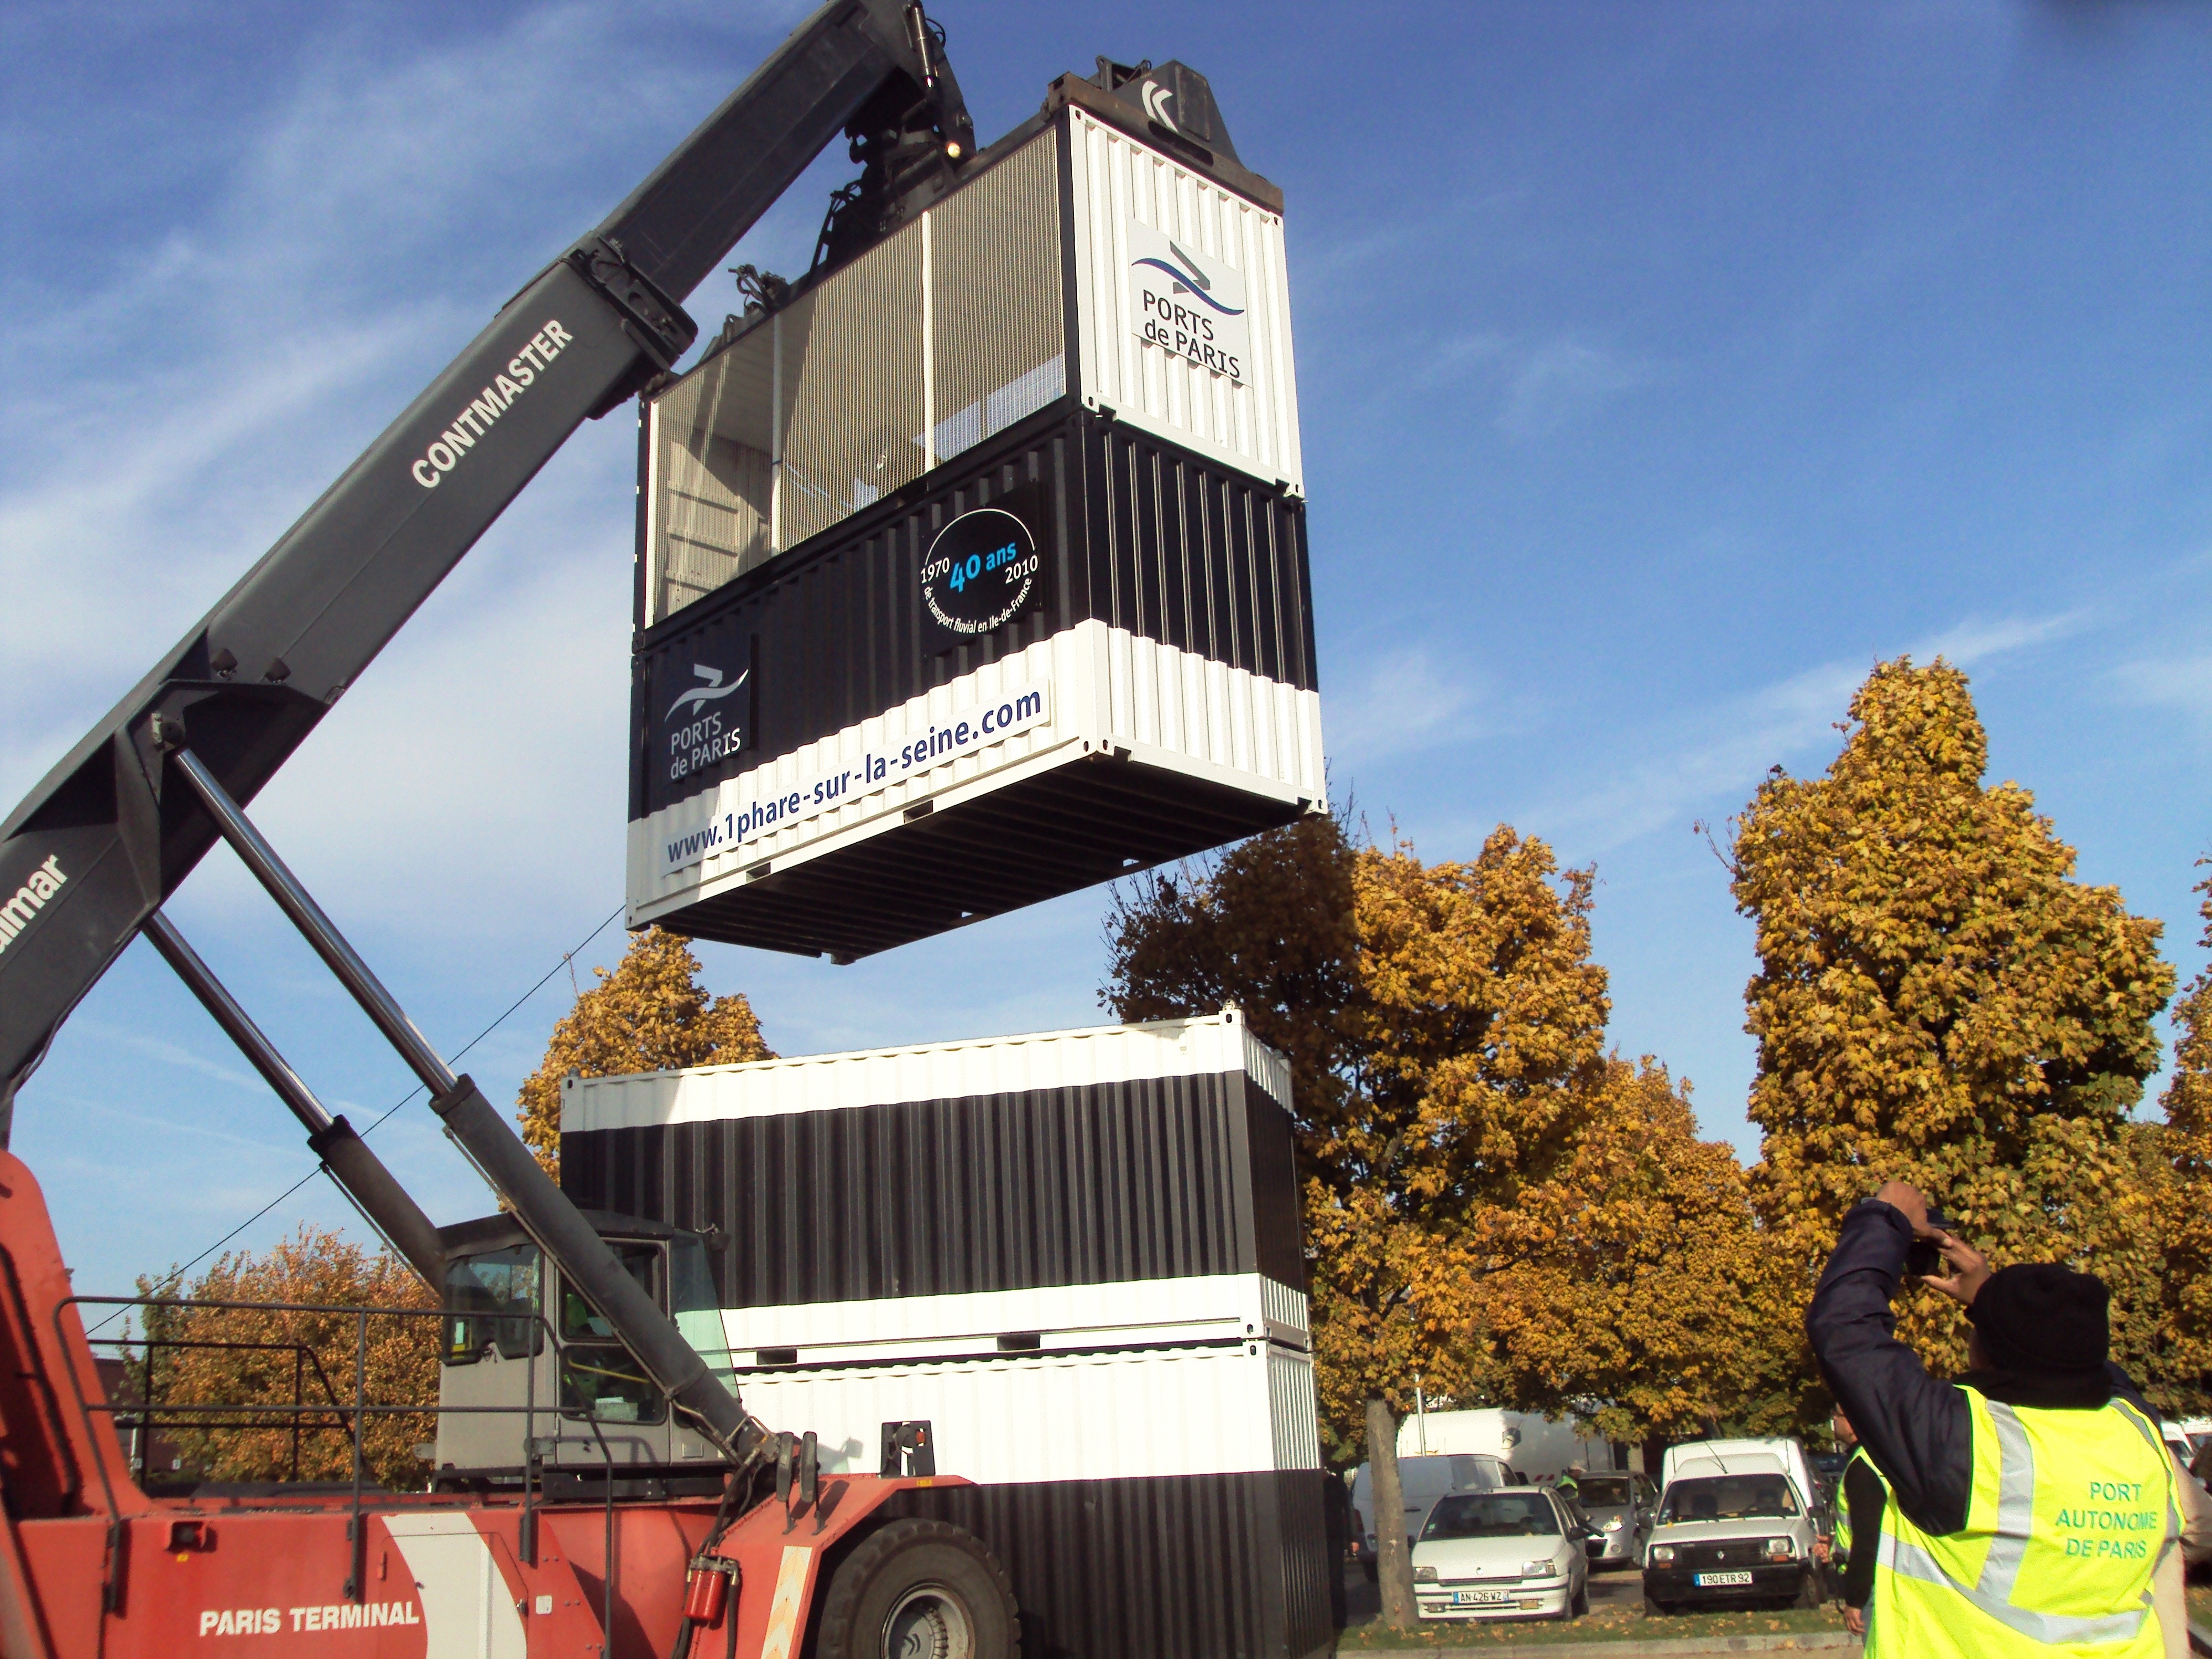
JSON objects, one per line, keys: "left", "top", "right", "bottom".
{"left": 562, "top": 1011, "right": 1343, "bottom": 1659}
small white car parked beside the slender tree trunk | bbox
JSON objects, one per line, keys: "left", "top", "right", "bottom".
{"left": 1413, "top": 1486, "right": 1590, "bottom": 1619}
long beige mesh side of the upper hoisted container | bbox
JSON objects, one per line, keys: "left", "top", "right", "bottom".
{"left": 644, "top": 128, "right": 1068, "bottom": 626}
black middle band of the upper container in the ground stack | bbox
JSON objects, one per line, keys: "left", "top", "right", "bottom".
{"left": 560, "top": 1071, "right": 1305, "bottom": 1307}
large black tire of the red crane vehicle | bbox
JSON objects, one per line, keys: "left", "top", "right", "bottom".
{"left": 818, "top": 1520, "right": 1020, "bottom": 1659}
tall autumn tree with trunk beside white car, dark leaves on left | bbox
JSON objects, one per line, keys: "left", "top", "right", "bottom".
{"left": 1104, "top": 818, "right": 1717, "bottom": 1621}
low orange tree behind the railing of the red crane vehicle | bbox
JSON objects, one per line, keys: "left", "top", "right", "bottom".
{"left": 134, "top": 1223, "right": 438, "bottom": 1491}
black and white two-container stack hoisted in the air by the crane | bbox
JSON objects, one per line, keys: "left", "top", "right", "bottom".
{"left": 628, "top": 64, "right": 1325, "bottom": 958}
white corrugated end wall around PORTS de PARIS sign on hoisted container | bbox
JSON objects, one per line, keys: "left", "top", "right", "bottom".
{"left": 1068, "top": 108, "right": 1305, "bottom": 491}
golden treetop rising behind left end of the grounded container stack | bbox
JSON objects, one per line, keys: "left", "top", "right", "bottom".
{"left": 515, "top": 927, "right": 774, "bottom": 1177}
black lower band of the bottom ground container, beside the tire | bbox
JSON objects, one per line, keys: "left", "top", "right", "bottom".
{"left": 885, "top": 1469, "right": 1345, "bottom": 1659}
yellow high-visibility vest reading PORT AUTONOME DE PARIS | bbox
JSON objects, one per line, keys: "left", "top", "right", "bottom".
{"left": 1867, "top": 1389, "right": 2181, "bottom": 1659}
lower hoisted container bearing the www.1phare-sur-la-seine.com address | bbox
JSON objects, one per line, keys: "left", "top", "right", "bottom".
{"left": 628, "top": 411, "right": 1325, "bottom": 956}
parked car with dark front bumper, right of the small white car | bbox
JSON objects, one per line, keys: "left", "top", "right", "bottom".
{"left": 1644, "top": 1453, "right": 1825, "bottom": 1613}
